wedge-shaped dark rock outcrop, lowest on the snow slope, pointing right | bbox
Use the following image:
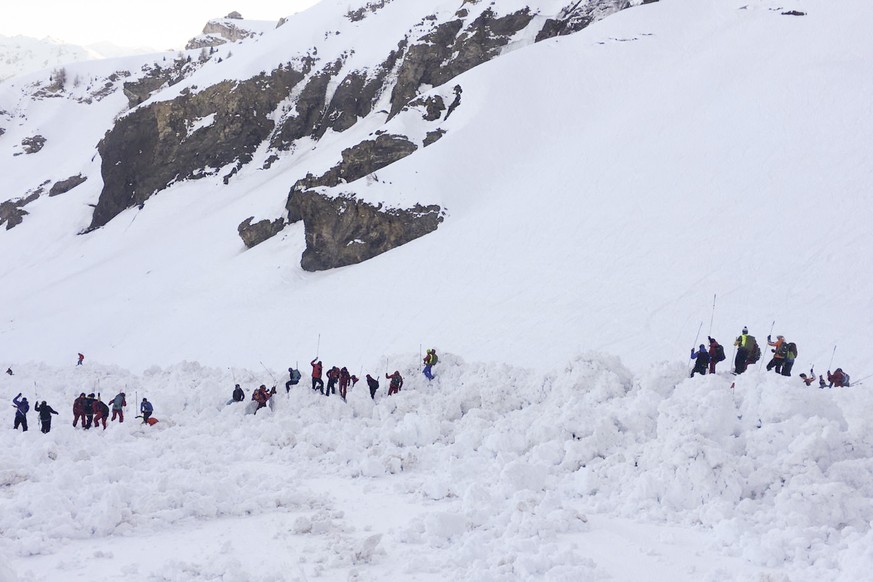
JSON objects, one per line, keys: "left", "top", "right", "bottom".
{"left": 293, "top": 190, "right": 443, "bottom": 271}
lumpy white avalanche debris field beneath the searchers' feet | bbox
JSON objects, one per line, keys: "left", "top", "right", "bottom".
{"left": 0, "top": 354, "right": 873, "bottom": 580}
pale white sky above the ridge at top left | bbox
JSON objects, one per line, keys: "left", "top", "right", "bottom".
{"left": 0, "top": 0, "right": 319, "bottom": 49}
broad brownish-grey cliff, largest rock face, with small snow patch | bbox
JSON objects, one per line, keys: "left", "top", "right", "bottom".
{"left": 89, "top": 68, "right": 304, "bottom": 230}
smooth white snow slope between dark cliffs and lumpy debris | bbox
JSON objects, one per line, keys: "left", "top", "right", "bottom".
{"left": 0, "top": 2, "right": 871, "bottom": 377}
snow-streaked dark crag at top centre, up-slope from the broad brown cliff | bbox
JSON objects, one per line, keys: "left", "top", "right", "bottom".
{"left": 390, "top": 8, "right": 533, "bottom": 117}
